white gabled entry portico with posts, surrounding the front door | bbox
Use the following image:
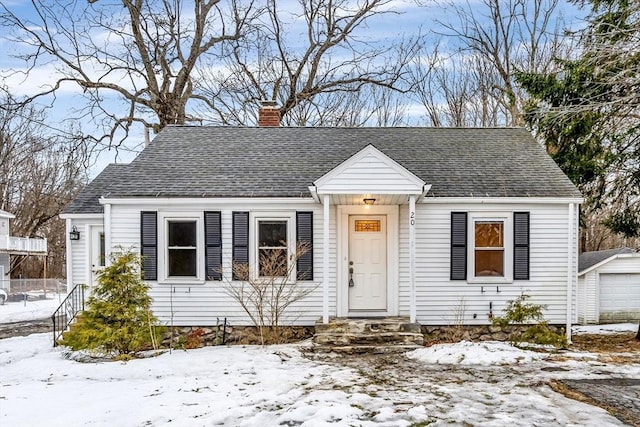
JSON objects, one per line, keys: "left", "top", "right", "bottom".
{"left": 309, "top": 145, "right": 430, "bottom": 329}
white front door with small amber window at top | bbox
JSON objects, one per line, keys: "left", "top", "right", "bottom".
{"left": 348, "top": 215, "right": 387, "bottom": 311}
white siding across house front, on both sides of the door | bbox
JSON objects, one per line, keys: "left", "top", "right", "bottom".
{"left": 99, "top": 200, "right": 577, "bottom": 326}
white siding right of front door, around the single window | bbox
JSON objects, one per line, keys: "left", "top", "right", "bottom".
{"left": 400, "top": 202, "right": 568, "bottom": 325}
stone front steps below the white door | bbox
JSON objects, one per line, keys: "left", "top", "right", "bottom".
{"left": 313, "top": 316, "right": 424, "bottom": 354}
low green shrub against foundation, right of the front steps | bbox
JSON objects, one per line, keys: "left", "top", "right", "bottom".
{"left": 493, "top": 294, "right": 567, "bottom": 348}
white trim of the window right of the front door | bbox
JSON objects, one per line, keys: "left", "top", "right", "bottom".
{"left": 467, "top": 212, "right": 513, "bottom": 285}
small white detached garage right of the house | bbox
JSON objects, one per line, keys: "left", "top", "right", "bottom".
{"left": 576, "top": 248, "right": 640, "bottom": 324}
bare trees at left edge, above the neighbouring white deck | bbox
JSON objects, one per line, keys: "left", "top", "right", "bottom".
{"left": 0, "top": 89, "right": 89, "bottom": 280}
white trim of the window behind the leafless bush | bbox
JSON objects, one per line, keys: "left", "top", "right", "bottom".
{"left": 249, "top": 211, "right": 297, "bottom": 283}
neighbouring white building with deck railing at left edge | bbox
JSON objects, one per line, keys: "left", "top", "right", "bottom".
{"left": 0, "top": 210, "right": 47, "bottom": 293}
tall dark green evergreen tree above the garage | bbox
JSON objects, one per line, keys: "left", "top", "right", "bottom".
{"left": 516, "top": 0, "right": 640, "bottom": 241}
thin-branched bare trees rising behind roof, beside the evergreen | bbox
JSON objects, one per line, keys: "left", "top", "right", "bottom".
{"left": 417, "top": 0, "right": 564, "bottom": 126}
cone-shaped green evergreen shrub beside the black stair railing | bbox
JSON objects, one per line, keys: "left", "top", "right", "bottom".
{"left": 60, "top": 252, "right": 162, "bottom": 359}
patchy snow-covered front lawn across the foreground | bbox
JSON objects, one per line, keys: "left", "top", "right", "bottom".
{"left": 0, "top": 325, "right": 640, "bottom": 427}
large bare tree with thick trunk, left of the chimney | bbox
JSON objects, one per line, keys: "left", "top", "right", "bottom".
{"left": 0, "top": 0, "right": 258, "bottom": 150}
